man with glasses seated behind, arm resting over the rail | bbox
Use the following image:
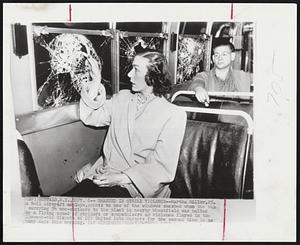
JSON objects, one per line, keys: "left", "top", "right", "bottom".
{"left": 187, "top": 39, "right": 251, "bottom": 106}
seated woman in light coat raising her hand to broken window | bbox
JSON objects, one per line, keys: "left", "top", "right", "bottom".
{"left": 65, "top": 52, "right": 186, "bottom": 197}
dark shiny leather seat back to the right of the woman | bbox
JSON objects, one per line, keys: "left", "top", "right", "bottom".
{"left": 170, "top": 120, "right": 253, "bottom": 198}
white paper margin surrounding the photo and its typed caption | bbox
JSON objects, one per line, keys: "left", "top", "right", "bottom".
{"left": 3, "top": 4, "right": 296, "bottom": 241}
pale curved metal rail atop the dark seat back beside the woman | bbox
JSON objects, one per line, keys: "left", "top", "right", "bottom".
{"left": 180, "top": 106, "right": 254, "bottom": 135}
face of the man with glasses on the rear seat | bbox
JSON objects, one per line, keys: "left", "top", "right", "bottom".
{"left": 213, "top": 45, "right": 235, "bottom": 69}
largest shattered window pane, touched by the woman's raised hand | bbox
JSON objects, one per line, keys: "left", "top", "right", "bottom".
{"left": 33, "top": 25, "right": 111, "bottom": 109}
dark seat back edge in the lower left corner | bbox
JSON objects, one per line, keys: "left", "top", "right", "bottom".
{"left": 18, "top": 139, "right": 43, "bottom": 197}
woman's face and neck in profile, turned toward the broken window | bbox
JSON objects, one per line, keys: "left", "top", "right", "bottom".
{"left": 128, "top": 56, "right": 153, "bottom": 93}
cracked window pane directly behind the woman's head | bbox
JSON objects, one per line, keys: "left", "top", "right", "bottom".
{"left": 120, "top": 37, "right": 163, "bottom": 90}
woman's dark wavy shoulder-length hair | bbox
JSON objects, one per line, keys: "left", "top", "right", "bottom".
{"left": 137, "top": 51, "right": 172, "bottom": 97}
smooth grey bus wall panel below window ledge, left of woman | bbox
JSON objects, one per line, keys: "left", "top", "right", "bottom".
{"left": 23, "top": 121, "right": 107, "bottom": 195}
